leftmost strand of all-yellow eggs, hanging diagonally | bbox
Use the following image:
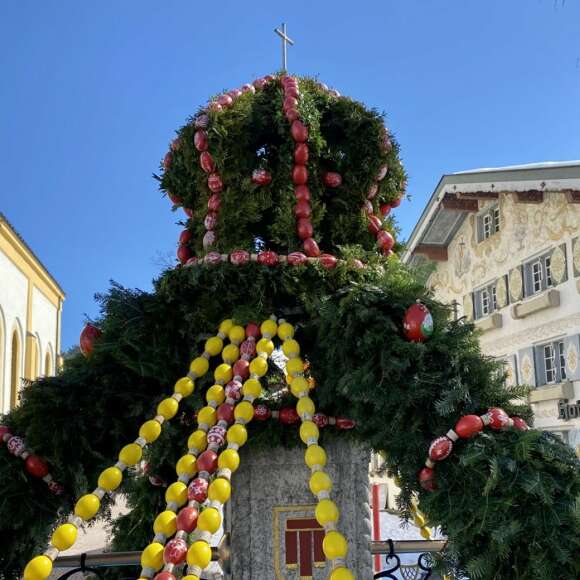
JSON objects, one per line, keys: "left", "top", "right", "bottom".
{"left": 24, "top": 320, "right": 233, "bottom": 580}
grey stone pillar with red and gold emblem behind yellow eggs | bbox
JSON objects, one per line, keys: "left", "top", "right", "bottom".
{"left": 228, "top": 440, "right": 373, "bottom": 580}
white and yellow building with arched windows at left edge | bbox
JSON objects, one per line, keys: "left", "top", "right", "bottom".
{"left": 0, "top": 214, "right": 64, "bottom": 414}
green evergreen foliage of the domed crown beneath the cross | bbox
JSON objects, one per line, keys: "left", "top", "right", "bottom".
{"left": 161, "top": 78, "right": 405, "bottom": 255}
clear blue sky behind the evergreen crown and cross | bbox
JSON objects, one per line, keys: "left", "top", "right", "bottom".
{"left": 0, "top": 0, "right": 580, "bottom": 348}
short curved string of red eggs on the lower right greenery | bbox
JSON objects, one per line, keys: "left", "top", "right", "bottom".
{"left": 417, "top": 407, "right": 529, "bottom": 492}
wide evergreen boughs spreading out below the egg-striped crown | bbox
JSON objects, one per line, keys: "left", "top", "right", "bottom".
{"left": 0, "top": 260, "right": 580, "bottom": 579}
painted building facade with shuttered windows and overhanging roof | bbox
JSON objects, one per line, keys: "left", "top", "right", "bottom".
{"left": 403, "top": 161, "right": 580, "bottom": 456}
